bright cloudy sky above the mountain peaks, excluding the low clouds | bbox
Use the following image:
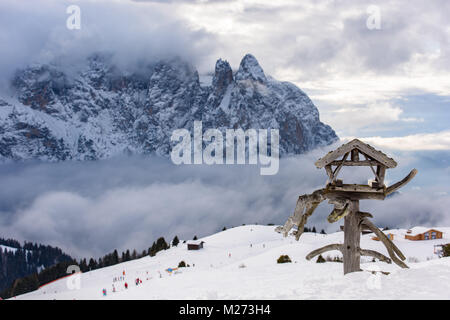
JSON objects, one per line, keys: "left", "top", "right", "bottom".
{"left": 0, "top": 0, "right": 450, "bottom": 145}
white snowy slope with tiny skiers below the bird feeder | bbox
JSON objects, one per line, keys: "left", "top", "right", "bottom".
{"left": 15, "top": 225, "right": 450, "bottom": 299}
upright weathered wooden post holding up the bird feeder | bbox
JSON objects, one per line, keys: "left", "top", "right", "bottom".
{"left": 342, "top": 200, "right": 361, "bottom": 274}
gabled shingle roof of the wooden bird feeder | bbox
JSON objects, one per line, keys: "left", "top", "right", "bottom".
{"left": 315, "top": 139, "right": 397, "bottom": 168}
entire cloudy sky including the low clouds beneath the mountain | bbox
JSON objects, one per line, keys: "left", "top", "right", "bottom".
{"left": 0, "top": 0, "right": 450, "bottom": 255}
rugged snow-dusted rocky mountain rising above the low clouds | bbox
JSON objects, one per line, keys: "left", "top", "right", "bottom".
{"left": 0, "top": 54, "right": 337, "bottom": 161}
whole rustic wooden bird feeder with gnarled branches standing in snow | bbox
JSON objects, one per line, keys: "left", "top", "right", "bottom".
{"left": 276, "top": 139, "right": 417, "bottom": 274}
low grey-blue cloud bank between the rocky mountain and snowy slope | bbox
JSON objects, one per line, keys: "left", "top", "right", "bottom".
{"left": 0, "top": 146, "right": 450, "bottom": 257}
